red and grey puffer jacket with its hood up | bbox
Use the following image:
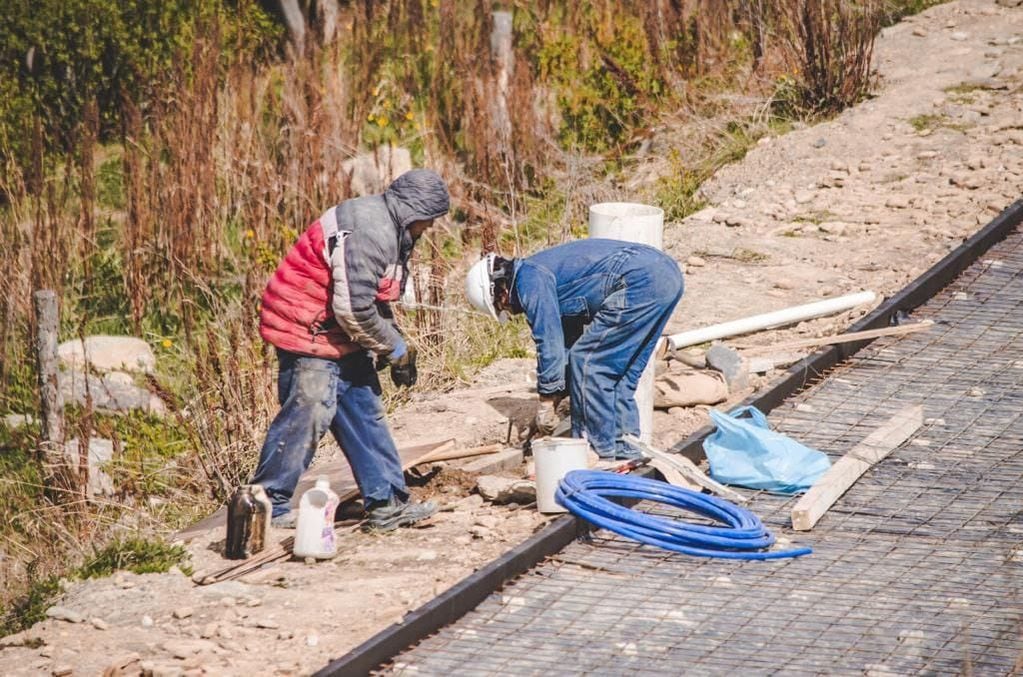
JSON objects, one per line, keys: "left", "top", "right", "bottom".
{"left": 260, "top": 170, "right": 449, "bottom": 359}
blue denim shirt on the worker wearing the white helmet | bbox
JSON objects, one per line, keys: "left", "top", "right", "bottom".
{"left": 510, "top": 238, "right": 661, "bottom": 395}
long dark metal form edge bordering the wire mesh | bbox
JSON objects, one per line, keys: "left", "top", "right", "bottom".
{"left": 315, "top": 199, "right": 1023, "bottom": 677}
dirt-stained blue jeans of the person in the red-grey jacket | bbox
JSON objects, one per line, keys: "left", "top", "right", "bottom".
{"left": 251, "top": 349, "right": 408, "bottom": 516}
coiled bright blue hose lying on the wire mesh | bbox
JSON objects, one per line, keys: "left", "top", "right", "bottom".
{"left": 554, "top": 470, "right": 812, "bottom": 559}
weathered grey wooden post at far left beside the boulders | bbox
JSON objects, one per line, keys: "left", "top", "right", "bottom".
{"left": 32, "top": 289, "right": 68, "bottom": 477}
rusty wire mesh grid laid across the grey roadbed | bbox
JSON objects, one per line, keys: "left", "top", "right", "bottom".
{"left": 384, "top": 232, "right": 1023, "bottom": 675}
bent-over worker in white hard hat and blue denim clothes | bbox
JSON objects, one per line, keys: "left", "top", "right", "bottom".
{"left": 465, "top": 238, "right": 682, "bottom": 460}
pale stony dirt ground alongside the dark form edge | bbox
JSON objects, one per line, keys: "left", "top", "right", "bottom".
{"left": 0, "top": 0, "right": 1023, "bottom": 675}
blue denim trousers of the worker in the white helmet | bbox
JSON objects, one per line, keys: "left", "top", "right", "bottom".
{"left": 568, "top": 252, "right": 682, "bottom": 458}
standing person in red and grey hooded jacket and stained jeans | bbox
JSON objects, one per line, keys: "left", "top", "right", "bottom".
{"left": 252, "top": 170, "right": 449, "bottom": 531}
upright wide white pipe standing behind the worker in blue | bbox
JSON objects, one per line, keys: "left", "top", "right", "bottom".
{"left": 589, "top": 202, "right": 664, "bottom": 444}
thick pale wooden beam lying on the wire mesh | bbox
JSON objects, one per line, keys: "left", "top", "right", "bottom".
{"left": 792, "top": 405, "right": 924, "bottom": 531}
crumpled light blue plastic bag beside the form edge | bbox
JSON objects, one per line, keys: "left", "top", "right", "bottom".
{"left": 704, "top": 407, "right": 831, "bottom": 494}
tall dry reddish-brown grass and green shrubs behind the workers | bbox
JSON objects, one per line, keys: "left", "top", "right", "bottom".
{"left": 0, "top": 0, "right": 934, "bottom": 634}
